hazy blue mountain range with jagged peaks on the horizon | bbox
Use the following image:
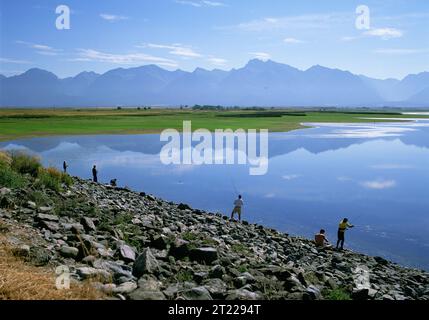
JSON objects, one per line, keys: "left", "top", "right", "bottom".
{"left": 0, "top": 59, "right": 429, "bottom": 107}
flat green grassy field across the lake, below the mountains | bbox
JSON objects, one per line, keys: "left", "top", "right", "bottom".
{"left": 0, "top": 109, "right": 427, "bottom": 140}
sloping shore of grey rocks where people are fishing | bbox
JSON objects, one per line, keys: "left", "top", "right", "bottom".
{"left": 0, "top": 178, "right": 429, "bottom": 300}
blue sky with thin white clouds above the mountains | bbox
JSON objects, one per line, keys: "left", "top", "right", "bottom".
{"left": 0, "top": 0, "right": 429, "bottom": 78}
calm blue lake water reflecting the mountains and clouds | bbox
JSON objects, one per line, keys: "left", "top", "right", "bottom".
{"left": 0, "top": 120, "right": 429, "bottom": 270}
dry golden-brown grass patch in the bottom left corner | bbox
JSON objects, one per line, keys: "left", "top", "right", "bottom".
{"left": 0, "top": 221, "right": 105, "bottom": 300}
